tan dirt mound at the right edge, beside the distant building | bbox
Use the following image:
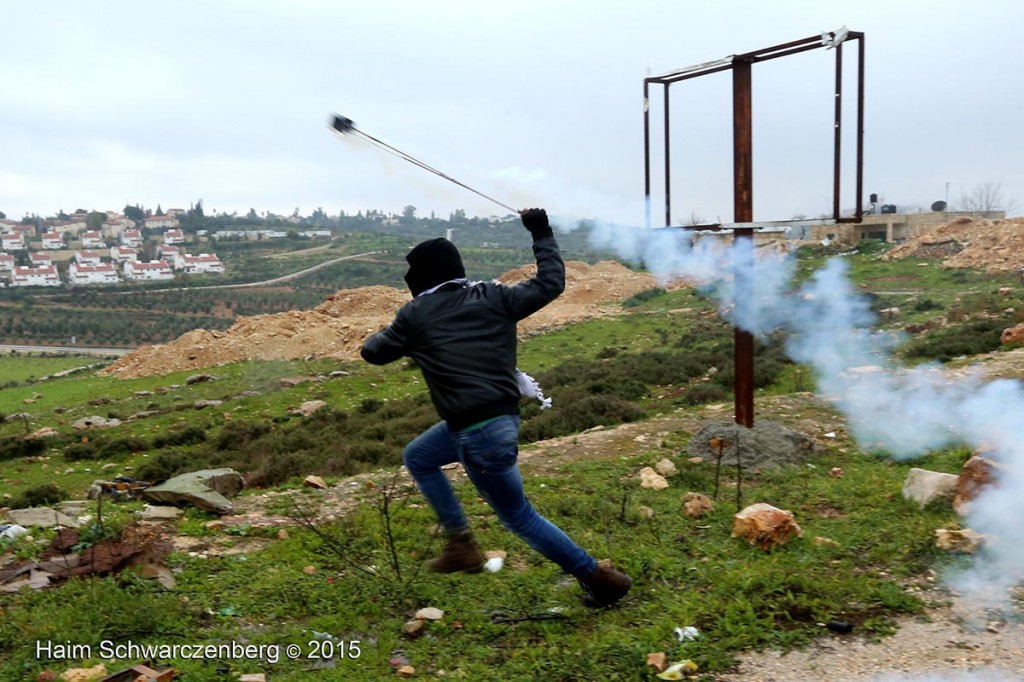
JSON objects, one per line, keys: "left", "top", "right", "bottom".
{"left": 885, "top": 217, "right": 1024, "bottom": 273}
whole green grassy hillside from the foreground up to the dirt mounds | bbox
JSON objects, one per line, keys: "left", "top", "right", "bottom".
{"left": 0, "top": 245, "right": 1024, "bottom": 681}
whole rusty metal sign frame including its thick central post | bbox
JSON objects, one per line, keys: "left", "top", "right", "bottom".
{"left": 643, "top": 28, "right": 864, "bottom": 428}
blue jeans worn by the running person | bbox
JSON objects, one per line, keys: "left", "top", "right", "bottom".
{"left": 402, "top": 415, "right": 597, "bottom": 578}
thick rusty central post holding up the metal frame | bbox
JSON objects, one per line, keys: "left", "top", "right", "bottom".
{"left": 732, "top": 60, "right": 754, "bottom": 428}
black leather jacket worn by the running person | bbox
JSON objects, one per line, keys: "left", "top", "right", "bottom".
{"left": 361, "top": 237, "right": 565, "bottom": 431}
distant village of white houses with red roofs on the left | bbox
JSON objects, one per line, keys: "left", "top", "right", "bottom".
{"left": 0, "top": 204, "right": 331, "bottom": 287}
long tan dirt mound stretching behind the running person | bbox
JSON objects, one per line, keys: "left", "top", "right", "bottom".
{"left": 100, "top": 261, "right": 654, "bottom": 379}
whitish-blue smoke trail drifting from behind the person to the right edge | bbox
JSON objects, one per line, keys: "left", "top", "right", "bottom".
{"left": 555, "top": 219, "right": 1024, "bottom": 606}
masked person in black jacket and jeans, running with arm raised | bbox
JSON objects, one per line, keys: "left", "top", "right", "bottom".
{"left": 361, "top": 209, "right": 633, "bottom": 606}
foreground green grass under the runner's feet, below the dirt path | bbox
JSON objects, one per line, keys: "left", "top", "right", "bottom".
{"left": 0, "top": 444, "right": 951, "bottom": 681}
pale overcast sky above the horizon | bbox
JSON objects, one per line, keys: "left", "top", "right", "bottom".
{"left": 0, "top": 0, "right": 1024, "bottom": 224}
